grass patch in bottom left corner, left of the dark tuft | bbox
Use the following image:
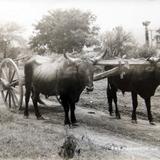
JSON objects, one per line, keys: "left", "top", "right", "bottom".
{"left": 0, "top": 111, "right": 64, "bottom": 159}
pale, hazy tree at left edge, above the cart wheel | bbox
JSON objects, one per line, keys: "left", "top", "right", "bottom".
{"left": 0, "top": 23, "right": 26, "bottom": 58}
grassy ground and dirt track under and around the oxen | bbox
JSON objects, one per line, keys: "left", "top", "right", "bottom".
{"left": 0, "top": 80, "right": 160, "bottom": 160}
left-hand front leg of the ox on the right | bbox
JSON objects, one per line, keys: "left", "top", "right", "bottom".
{"left": 131, "top": 92, "right": 138, "bottom": 123}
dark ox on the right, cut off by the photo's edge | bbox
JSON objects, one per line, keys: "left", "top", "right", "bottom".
{"left": 105, "top": 60, "right": 160, "bottom": 125}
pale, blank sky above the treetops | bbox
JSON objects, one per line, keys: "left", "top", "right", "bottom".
{"left": 0, "top": 0, "right": 160, "bottom": 44}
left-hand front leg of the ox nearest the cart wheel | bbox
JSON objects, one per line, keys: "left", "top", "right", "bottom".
{"left": 60, "top": 96, "right": 71, "bottom": 125}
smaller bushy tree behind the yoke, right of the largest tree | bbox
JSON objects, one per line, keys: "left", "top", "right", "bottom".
{"left": 102, "top": 26, "right": 136, "bottom": 57}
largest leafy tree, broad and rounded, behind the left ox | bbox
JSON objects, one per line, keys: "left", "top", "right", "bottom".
{"left": 29, "top": 9, "right": 98, "bottom": 54}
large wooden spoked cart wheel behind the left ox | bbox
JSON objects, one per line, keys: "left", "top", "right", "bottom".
{"left": 0, "top": 58, "right": 23, "bottom": 112}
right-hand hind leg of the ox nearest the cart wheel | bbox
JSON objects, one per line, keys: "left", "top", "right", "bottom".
{"left": 32, "top": 91, "right": 44, "bottom": 120}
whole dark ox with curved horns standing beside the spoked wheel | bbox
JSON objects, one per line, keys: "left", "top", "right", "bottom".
{"left": 24, "top": 52, "right": 106, "bottom": 124}
